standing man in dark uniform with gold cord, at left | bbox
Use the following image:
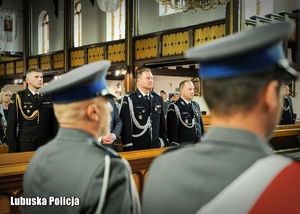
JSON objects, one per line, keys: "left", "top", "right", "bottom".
{"left": 6, "top": 68, "right": 57, "bottom": 152}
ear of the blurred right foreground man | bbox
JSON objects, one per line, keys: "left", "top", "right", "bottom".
{"left": 264, "top": 80, "right": 280, "bottom": 111}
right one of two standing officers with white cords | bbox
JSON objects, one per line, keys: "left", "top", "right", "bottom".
{"left": 167, "top": 80, "right": 204, "bottom": 146}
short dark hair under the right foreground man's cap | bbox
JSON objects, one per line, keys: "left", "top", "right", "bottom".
{"left": 202, "top": 70, "right": 283, "bottom": 116}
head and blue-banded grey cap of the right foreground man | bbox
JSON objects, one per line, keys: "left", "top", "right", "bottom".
{"left": 185, "top": 22, "right": 297, "bottom": 137}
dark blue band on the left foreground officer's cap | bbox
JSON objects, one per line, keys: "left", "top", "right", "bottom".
{"left": 52, "top": 78, "right": 107, "bottom": 103}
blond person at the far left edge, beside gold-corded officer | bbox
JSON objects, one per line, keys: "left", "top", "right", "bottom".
{"left": 0, "top": 89, "right": 11, "bottom": 144}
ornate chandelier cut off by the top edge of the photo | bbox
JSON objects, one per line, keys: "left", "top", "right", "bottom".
{"left": 156, "top": 0, "right": 230, "bottom": 12}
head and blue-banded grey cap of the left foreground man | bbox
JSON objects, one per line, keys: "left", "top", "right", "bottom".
{"left": 40, "top": 60, "right": 114, "bottom": 137}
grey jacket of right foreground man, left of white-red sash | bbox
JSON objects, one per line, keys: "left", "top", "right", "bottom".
{"left": 142, "top": 127, "right": 272, "bottom": 214}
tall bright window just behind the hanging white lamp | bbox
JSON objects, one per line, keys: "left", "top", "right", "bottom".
{"left": 106, "top": 0, "right": 126, "bottom": 41}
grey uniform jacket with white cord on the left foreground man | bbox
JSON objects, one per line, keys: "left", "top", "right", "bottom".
{"left": 22, "top": 128, "right": 139, "bottom": 214}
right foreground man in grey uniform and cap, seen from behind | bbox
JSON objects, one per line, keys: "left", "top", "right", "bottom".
{"left": 142, "top": 22, "right": 298, "bottom": 214}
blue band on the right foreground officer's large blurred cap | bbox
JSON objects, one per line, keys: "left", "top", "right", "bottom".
{"left": 199, "top": 44, "right": 284, "bottom": 78}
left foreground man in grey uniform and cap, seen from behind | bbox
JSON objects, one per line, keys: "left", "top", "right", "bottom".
{"left": 22, "top": 60, "right": 140, "bottom": 214}
